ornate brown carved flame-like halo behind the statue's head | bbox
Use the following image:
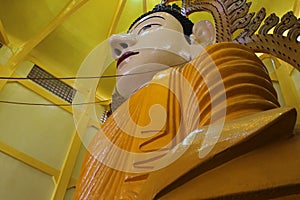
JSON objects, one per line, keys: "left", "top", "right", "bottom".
{"left": 164, "top": 0, "right": 300, "bottom": 71}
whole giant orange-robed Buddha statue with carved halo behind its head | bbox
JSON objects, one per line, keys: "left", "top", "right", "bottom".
{"left": 73, "top": 0, "right": 300, "bottom": 200}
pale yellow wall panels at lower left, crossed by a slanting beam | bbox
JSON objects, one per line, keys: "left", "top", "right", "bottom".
{"left": 0, "top": 80, "right": 75, "bottom": 200}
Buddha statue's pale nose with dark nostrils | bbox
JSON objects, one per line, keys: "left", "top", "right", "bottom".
{"left": 109, "top": 34, "right": 136, "bottom": 60}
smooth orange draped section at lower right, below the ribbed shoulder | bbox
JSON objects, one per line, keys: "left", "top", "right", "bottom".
{"left": 138, "top": 108, "right": 300, "bottom": 200}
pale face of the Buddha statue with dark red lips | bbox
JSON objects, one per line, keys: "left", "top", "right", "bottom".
{"left": 110, "top": 12, "right": 191, "bottom": 98}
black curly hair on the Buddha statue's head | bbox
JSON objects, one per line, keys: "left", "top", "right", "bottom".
{"left": 128, "top": 4, "right": 194, "bottom": 36}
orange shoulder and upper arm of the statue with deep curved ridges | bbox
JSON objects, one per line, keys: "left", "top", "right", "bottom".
{"left": 178, "top": 43, "right": 279, "bottom": 126}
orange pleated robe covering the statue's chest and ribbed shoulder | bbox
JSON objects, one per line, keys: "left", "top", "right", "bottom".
{"left": 73, "top": 43, "right": 279, "bottom": 200}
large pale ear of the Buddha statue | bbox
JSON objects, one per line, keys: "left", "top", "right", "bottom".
{"left": 190, "top": 20, "right": 216, "bottom": 47}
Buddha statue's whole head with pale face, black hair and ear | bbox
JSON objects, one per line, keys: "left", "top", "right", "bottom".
{"left": 110, "top": 4, "right": 215, "bottom": 98}
